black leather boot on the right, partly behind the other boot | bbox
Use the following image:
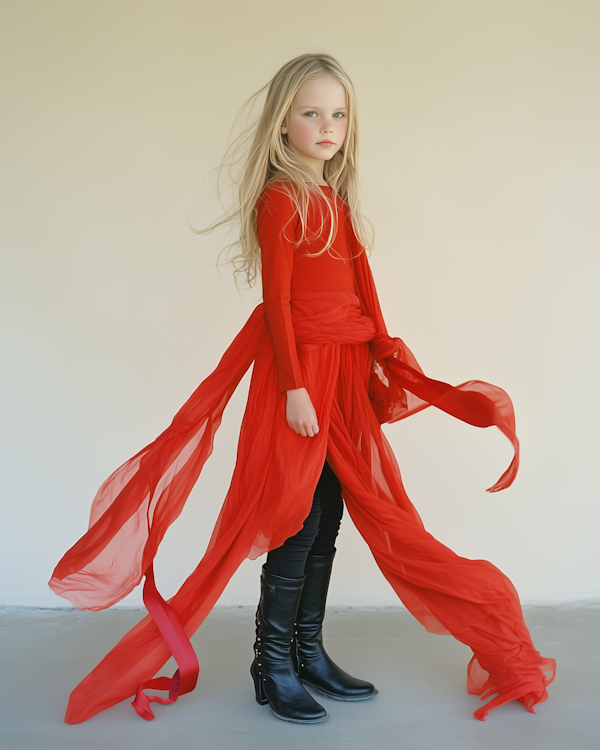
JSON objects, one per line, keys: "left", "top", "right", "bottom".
{"left": 292, "top": 552, "right": 379, "bottom": 701}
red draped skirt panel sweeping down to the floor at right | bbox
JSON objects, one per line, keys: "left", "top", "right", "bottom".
{"left": 327, "top": 347, "right": 556, "bottom": 720}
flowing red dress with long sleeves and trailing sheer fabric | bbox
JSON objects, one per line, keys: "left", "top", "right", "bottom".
{"left": 50, "top": 179, "right": 556, "bottom": 723}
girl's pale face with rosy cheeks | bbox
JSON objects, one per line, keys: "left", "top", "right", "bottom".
{"left": 281, "top": 73, "right": 348, "bottom": 182}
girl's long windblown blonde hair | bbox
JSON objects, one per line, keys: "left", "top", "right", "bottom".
{"left": 192, "top": 53, "right": 374, "bottom": 286}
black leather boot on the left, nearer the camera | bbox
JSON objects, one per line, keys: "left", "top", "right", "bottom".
{"left": 250, "top": 565, "right": 329, "bottom": 724}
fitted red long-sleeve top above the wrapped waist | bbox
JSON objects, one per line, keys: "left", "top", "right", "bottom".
{"left": 257, "top": 183, "right": 356, "bottom": 391}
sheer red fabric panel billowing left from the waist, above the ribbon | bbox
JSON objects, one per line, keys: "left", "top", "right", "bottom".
{"left": 48, "top": 306, "right": 265, "bottom": 610}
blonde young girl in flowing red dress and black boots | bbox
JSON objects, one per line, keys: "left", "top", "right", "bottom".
{"left": 50, "top": 54, "right": 555, "bottom": 723}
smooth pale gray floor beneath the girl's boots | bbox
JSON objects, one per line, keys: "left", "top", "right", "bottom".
{"left": 0, "top": 606, "right": 600, "bottom": 750}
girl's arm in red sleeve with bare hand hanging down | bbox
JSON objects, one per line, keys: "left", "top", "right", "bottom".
{"left": 257, "top": 188, "right": 319, "bottom": 437}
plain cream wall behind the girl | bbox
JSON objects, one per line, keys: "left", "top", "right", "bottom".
{"left": 0, "top": 0, "right": 600, "bottom": 607}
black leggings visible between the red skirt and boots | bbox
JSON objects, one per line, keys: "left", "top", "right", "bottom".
{"left": 266, "top": 461, "right": 344, "bottom": 578}
